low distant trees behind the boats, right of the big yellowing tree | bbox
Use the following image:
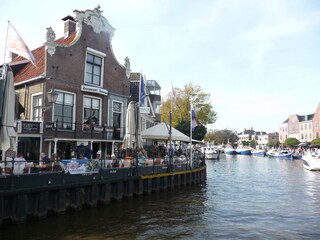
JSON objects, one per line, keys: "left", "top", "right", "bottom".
{"left": 204, "top": 129, "right": 238, "bottom": 145}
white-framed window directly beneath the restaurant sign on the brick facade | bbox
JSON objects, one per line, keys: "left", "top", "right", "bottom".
{"left": 83, "top": 97, "right": 101, "bottom": 125}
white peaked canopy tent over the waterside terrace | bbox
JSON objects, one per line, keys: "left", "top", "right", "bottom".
{"left": 140, "top": 122, "right": 190, "bottom": 142}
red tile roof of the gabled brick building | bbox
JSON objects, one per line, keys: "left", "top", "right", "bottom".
{"left": 11, "top": 32, "right": 77, "bottom": 83}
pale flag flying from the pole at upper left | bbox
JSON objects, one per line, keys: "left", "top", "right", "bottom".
{"left": 7, "top": 22, "right": 36, "bottom": 66}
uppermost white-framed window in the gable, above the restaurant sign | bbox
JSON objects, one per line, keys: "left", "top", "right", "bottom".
{"left": 84, "top": 49, "right": 106, "bottom": 87}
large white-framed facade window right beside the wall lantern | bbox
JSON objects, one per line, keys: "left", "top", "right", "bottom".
{"left": 54, "top": 92, "right": 74, "bottom": 129}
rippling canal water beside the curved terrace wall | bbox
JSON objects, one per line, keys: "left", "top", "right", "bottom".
{"left": 0, "top": 155, "right": 320, "bottom": 240}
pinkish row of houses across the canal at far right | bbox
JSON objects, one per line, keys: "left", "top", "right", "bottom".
{"left": 279, "top": 103, "right": 320, "bottom": 143}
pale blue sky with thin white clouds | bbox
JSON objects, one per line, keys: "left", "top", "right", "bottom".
{"left": 0, "top": 0, "right": 320, "bottom": 133}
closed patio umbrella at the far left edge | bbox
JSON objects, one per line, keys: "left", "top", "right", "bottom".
{"left": 0, "top": 65, "right": 16, "bottom": 158}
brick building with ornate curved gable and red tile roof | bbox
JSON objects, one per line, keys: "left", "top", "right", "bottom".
{"left": 10, "top": 6, "right": 130, "bottom": 159}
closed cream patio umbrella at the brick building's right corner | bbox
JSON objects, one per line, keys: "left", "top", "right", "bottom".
{"left": 122, "top": 101, "right": 142, "bottom": 149}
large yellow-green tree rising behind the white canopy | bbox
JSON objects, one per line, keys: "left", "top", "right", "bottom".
{"left": 160, "top": 83, "right": 217, "bottom": 141}
